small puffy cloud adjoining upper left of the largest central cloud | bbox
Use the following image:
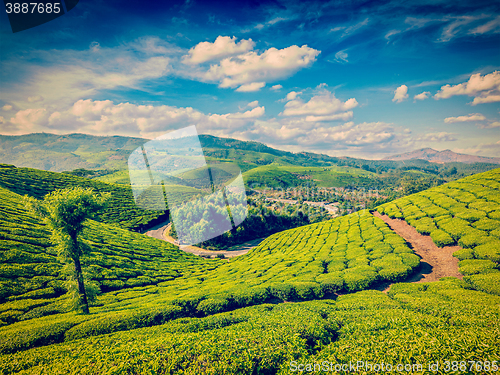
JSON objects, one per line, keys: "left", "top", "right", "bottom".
{"left": 183, "top": 36, "right": 255, "bottom": 64}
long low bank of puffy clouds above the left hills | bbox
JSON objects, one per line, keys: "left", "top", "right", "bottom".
{"left": 1, "top": 99, "right": 265, "bottom": 137}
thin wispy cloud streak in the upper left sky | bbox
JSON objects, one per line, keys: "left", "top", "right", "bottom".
{"left": 2, "top": 38, "right": 174, "bottom": 109}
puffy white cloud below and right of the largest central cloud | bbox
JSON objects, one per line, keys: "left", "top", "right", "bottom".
{"left": 281, "top": 90, "right": 358, "bottom": 116}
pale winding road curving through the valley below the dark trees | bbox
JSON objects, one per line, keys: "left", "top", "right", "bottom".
{"left": 145, "top": 223, "right": 265, "bottom": 258}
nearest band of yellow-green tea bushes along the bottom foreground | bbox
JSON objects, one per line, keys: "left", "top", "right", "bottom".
{"left": 0, "top": 279, "right": 500, "bottom": 374}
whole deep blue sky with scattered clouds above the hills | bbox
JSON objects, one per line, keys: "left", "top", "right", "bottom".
{"left": 0, "top": 0, "right": 500, "bottom": 158}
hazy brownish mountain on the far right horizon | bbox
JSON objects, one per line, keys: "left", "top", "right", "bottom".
{"left": 383, "top": 148, "right": 500, "bottom": 164}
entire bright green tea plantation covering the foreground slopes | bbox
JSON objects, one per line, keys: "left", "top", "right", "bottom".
{"left": 0, "top": 170, "right": 500, "bottom": 374}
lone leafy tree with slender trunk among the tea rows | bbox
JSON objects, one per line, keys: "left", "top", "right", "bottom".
{"left": 25, "top": 187, "right": 110, "bottom": 314}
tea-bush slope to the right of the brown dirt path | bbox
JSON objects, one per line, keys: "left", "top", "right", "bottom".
{"left": 377, "top": 169, "right": 500, "bottom": 294}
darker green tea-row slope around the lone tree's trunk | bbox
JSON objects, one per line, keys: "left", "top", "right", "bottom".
{"left": 0, "top": 188, "right": 215, "bottom": 324}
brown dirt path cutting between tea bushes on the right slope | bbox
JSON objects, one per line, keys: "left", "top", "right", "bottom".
{"left": 373, "top": 211, "right": 463, "bottom": 291}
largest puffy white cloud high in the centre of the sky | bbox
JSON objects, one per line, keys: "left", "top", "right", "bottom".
{"left": 200, "top": 45, "right": 320, "bottom": 91}
